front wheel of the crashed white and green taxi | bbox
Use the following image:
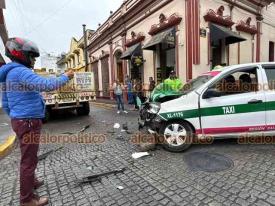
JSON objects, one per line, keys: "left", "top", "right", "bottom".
{"left": 159, "top": 121, "right": 194, "bottom": 152}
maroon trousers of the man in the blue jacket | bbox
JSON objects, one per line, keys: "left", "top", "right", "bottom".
{"left": 11, "top": 119, "right": 42, "bottom": 204}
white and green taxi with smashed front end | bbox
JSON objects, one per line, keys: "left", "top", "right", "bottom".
{"left": 143, "top": 62, "right": 275, "bottom": 152}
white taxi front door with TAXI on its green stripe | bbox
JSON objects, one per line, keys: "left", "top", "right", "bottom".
{"left": 200, "top": 66, "right": 266, "bottom": 136}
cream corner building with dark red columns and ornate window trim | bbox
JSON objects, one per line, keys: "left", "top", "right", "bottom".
{"left": 88, "top": 0, "right": 275, "bottom": 97}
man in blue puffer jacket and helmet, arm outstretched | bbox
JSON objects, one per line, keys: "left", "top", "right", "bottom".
{"left": 0, "top": 38, "right": 74, "bottom": 206}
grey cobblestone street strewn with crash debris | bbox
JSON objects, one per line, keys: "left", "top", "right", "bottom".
{"left": 0, "top": 105, "right": 275, "bottom": 206}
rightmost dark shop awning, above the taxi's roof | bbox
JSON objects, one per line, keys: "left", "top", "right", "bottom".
{"left": 210, "top": 24, "right": 246, "bottom": 45}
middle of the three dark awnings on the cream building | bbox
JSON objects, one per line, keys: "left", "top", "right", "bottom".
{"left": 143, "top": 28, "right": 175, "bottom": 50}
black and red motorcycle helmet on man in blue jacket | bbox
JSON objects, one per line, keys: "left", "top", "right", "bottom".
{"left": 6, "top": 37, "right": 40, "bottom": 67}
